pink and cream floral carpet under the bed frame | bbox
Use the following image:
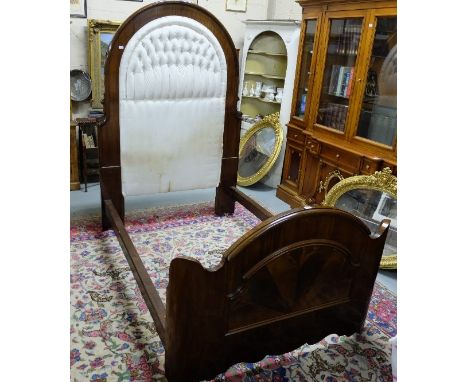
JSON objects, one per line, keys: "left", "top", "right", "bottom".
{"left": 70, "top": 203, "right": 396, "bottom": 382}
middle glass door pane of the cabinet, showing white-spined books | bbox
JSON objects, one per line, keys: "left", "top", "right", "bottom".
{"left": 317, "top": 17, "right": 363, "bottom": 131}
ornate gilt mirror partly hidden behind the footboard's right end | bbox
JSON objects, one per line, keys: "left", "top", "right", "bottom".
{"left": 322, "top": 167, "right": 397, "bottom": 269}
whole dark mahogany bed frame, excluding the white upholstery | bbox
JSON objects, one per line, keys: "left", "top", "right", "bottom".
{"left": 99, "top": 2, "right": 389, "bottom": 381}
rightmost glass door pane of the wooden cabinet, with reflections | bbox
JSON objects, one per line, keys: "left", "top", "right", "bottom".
{"left": 356, "top": 16, "right": 397, "bottom": 146}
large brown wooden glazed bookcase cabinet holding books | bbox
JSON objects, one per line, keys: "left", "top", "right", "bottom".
{"left": 277, "top": 0, "right": 397, "bottom": 206}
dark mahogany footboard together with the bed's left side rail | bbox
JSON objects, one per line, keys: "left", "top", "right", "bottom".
{"left": 104, "top": 196, "right": 389, "bottom": 381}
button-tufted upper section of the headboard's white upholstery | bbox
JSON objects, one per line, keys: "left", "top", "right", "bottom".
{"left": 121, "top": 19, "right": 227, "bottom": 104}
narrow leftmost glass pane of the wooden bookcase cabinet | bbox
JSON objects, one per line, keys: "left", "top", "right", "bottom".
{"left": 294, "top": 20, "right": 317, "bottom": 119}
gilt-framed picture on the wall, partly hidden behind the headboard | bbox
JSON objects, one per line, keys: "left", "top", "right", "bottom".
{"left": 88, "top": 19, "right": 121, "bottom": 109}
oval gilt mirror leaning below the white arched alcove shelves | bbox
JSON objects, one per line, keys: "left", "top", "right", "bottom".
{"left": 237, "top": 113, "right": 283, "bottom": 186}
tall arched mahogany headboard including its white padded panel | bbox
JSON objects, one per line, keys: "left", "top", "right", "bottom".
{"left": 99, "top": 2, "right": 240, "bottom": 225}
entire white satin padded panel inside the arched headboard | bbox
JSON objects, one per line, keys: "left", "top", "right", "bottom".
{"left": 119, "top": 16, "right": 227, "bottom": 196}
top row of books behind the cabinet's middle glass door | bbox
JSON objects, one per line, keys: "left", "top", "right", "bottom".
{"left": 328, "top": 20, "right": 361, "bottom": 55}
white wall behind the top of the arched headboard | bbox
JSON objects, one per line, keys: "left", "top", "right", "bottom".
{"left": 70, "top": 0, "right": 301, "bottom": 117}
